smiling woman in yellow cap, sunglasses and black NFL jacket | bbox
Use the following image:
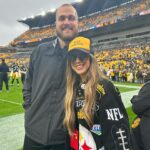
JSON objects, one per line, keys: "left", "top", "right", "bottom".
{"left": 64, "top": 37, "right": 132, "bottom": 150}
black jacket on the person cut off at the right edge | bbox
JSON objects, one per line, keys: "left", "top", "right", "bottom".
{"left": 131, "top": 81, "right": 150, "bottom": 150}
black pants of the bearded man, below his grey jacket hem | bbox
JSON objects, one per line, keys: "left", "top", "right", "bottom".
{"left": 23, "top": 136, "right": 65, "bottom": 150}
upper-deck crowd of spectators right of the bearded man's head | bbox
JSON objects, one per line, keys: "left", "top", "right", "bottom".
{"left": 79, "top": 1, "right": 150, "bottom": 31}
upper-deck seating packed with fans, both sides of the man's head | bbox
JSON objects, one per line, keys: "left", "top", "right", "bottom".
{"left": 11, "top": 0, "right": 150, "bottom": 46}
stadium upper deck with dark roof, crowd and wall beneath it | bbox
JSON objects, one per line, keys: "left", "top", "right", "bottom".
{"left": 11, "top": 0, "right": 150, "bottom": 46}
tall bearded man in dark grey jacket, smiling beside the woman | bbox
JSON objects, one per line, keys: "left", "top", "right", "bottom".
{"left": 23, "top": 4, "right": 78, "bottom": 150}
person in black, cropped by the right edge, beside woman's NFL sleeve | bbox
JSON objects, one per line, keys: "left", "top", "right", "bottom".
{"left": 131, "top": 72, "right": 150, "bottom": 150}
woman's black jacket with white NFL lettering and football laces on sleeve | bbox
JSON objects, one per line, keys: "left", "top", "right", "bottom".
{"left": 66, "top": 79, "right": 133, "bottom": 150}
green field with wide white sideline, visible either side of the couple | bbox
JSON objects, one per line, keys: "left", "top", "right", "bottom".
{"left": 0, "top": 82, "right": 140, "bottom": 150}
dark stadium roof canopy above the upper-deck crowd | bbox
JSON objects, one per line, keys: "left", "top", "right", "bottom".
{"left": 18, "top": 0, "right": 139, "bottom": 28}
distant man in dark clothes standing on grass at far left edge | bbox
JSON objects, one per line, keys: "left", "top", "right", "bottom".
{"left": 0, "top": 59, "right": 9, "bottom": 92}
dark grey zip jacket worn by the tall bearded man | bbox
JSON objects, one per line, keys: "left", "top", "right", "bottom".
{"left": 23, "top": 40, "right": 66, "bottom": 145}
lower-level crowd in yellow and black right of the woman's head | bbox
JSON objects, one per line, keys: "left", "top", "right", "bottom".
{"left": 95, "top": 45, "right": 150, "bottom": 84}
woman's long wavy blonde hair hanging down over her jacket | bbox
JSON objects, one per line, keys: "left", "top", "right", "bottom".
{"left": 64, "top": 56, "right": 103, "bottom": 135}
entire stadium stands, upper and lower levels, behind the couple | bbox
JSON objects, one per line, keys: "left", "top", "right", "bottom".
{"left": 0, "top": 0, "right": 150, "bottom": 83}
